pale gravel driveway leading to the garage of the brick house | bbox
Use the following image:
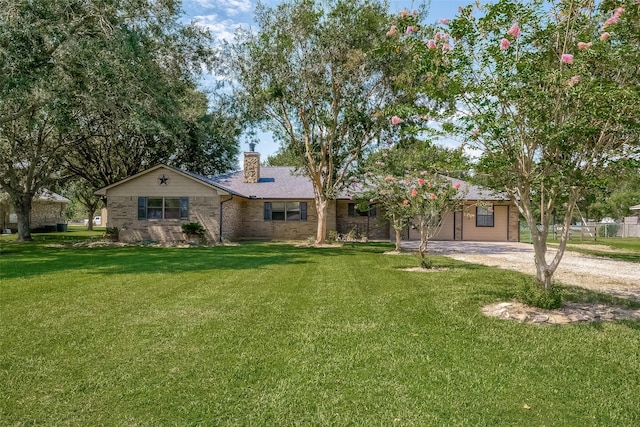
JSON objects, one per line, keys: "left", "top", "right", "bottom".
{"left": 402, "top": 241, "right": 640, "bottom": 301}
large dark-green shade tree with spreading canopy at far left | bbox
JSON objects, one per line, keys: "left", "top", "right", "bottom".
{"left": 0, "top": 0, "right": 218, "bottom": 241}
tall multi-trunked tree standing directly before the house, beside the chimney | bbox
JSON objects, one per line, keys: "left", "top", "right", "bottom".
{"left": 229, "top": 0, "right": 416, "bottom": 243}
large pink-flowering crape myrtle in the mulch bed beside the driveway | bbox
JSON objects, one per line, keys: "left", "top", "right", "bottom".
{"left": 392, "top": 0, "right": 640, "bottom": 290}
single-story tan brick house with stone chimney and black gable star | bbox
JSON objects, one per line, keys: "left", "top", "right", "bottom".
{"left": 96, "top": 151, "right": 519, "bottom": 241}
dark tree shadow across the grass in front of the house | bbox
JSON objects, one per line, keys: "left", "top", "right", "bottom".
{"left": 0, "top": 242, "right": 388, "bottom": 279}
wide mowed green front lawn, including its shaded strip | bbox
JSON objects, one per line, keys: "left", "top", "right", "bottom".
{"left": 0, "top": 242, "right": 640, "bottom": 426}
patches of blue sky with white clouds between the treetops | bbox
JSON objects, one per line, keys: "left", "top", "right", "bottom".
{"left": 182, "top": 0, "right": 473, "bottom": 164}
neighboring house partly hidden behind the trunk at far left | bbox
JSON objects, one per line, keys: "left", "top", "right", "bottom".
{"left": 0, "top": 190, "right": 69, "bottom": 232}
